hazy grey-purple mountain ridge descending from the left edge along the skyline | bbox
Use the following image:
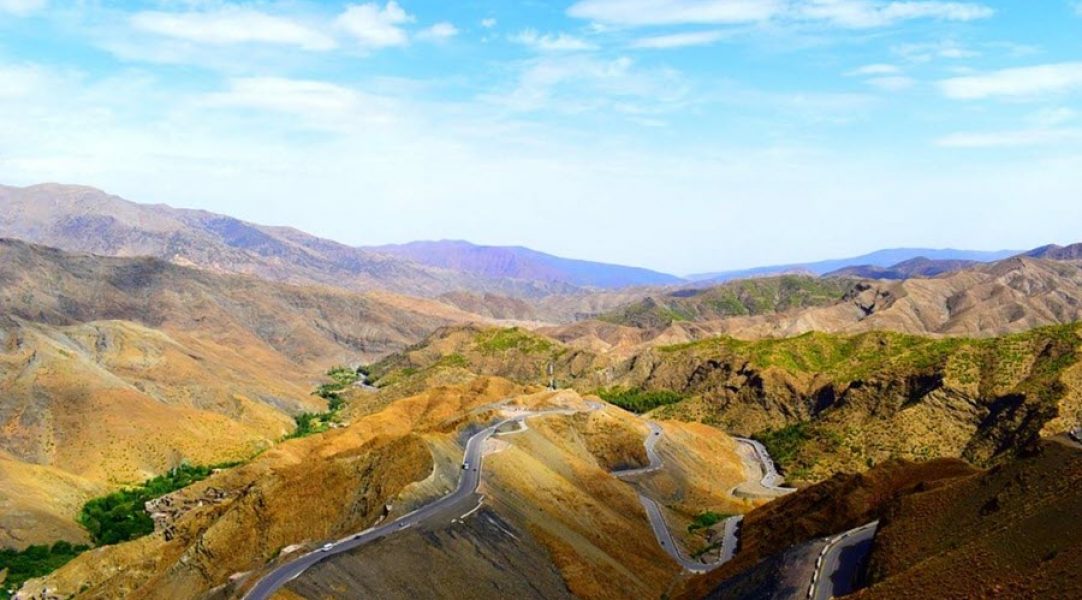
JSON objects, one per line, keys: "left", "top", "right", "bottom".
{"left": 0, "top": 184, "right": 568, "bottom": 296}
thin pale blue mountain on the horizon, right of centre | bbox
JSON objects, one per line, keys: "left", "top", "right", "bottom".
{"left": 687, "top": 248, "right": 1018, "bottom": 282}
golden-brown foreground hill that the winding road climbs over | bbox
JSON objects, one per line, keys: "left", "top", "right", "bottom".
{"left": 24, "top": 377, "right": 756, "bottom": 599}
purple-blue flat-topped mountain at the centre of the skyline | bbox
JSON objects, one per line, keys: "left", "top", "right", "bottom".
{"left": 367, "top": 240, "right": 683, "bottom": 289}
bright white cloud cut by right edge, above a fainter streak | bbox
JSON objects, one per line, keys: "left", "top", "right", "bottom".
{"left": 939, "top": 63, "right": 1082, "bottom": 99}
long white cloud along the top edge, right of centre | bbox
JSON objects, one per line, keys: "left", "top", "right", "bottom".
{"left": 567, "top": 0, "right": 994, "bottom": 28}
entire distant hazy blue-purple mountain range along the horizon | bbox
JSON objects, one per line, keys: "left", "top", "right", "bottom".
{"left": 0, "top": 184, "right": 1051, "bottom": 298}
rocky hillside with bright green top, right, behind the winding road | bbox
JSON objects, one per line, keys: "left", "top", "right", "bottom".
{"left": 373, "top": 324, "right": 1082, "bottom": 481}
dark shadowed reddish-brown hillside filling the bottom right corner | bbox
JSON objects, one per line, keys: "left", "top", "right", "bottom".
{"left": 678, "top": 440, "right": 1082, "bottom": 600}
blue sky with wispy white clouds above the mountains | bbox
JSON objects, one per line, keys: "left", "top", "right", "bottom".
{"left": 0, "top": 0, "right": 1082, "bottom": 275}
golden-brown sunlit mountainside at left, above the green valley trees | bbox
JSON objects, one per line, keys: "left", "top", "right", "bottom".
{"left": 0, "top": 240, "right": 493, "bottom": 545}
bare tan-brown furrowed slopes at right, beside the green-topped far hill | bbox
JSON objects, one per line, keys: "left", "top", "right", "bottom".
{"left": 575, "top": 257, "right": 1082, "bottom": 341}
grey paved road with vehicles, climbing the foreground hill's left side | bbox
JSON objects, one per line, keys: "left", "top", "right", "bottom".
{"left": 245, "top": 404, "right": 598, "bottom": 600}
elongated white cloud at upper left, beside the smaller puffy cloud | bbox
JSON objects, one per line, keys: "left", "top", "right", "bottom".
{"left": 131, "top": 8, "right": 335, "bottom": 50}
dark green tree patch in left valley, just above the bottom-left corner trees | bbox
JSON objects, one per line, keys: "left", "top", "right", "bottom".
{"left": 79, "top": 463, "right": 237, "bottom": 546}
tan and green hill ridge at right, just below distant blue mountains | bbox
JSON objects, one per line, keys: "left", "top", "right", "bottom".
{"left": 579, "top": 256, "right": 1082, "bottom": 344}
